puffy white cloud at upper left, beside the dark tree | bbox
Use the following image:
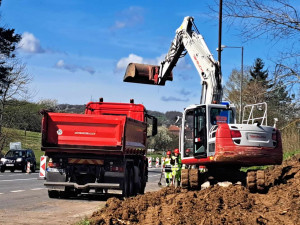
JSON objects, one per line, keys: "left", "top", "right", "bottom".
{"left": 18, "top": 32, "right": 45, "bottom": 53}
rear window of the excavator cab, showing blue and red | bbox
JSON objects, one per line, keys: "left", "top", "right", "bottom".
{"left": 210, "top": 108, "right": 234, "bottom": 125}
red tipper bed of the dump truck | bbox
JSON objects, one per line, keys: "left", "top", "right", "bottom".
{"left": 42, "top": 113, "right": 147, "bottom": 154}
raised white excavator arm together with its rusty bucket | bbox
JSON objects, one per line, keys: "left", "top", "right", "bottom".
{"left": 124, "top": 17, "right": 222, "bottom": 104}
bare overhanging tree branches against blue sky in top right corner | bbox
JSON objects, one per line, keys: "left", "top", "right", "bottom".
{"left": 219, "top": 0, "right": 300, "bottom": 90}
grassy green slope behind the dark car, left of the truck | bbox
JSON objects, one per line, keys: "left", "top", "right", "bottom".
{"left": 3, "top": 128, "right": 44, "bottom": 168}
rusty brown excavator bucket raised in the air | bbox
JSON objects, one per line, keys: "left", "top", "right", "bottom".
{"left": 123, "top": 63, "right": 173, "bottom": 85}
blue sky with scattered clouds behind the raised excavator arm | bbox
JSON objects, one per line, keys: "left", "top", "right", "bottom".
{"left": 0, "top": 0, "right": 288, "bottom": 112}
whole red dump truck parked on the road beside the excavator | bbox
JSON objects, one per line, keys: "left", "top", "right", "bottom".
{"left": 41, "top": 99, "right": 157, "bottom": 198}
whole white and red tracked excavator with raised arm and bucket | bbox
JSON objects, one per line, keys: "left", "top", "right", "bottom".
{"left": 123, "top": 16, "right": 283, "bottom": 192}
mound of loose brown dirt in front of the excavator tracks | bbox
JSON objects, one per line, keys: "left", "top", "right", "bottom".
{"left": 90, "top": 155, "right": 300, "bottom": 224}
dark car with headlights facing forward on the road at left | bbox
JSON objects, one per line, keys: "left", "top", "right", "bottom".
{"left": 0, "top": 149, "right": 36, "bottom": 173}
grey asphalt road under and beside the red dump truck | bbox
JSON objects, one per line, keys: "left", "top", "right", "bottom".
{"left": 0, "top": 168, "right": 164, "bottom": 224}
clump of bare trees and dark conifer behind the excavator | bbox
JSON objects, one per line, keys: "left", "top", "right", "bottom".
{"left": 224, "top": 59, "right": 299, "bottom": 127}
